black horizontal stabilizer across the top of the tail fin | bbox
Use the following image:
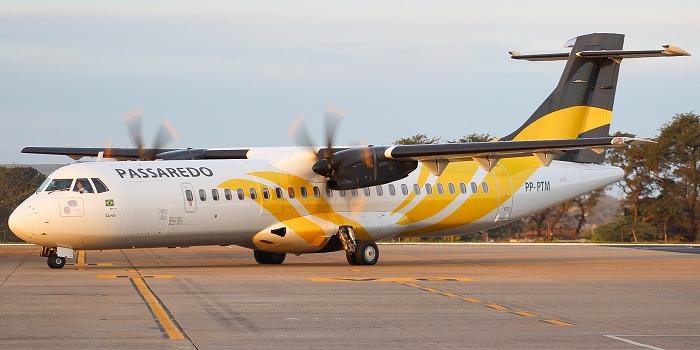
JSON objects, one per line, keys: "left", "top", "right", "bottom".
{"left": 509, "top": 45, "right": 690, "bottom": 61}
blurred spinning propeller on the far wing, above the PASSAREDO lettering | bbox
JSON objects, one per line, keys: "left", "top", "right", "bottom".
{"left": 123, "top": 109, "right": 179, "bottom": 160}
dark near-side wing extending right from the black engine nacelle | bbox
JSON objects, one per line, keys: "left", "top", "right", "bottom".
{"left": 384, "top": 137, "right": 654, "bottom": 173}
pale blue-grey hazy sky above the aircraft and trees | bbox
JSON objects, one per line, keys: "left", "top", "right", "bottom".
{"left": 0, "top": 0, "right": 700, "bottom": 164}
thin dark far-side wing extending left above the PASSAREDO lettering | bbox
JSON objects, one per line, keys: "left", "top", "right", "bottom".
{"left": 22, "top": 147, "right": 248, "bottom": 160}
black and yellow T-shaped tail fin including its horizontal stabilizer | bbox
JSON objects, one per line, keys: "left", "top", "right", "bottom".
{"left": 500, "top": 33, "right": 690, "bottom": 163}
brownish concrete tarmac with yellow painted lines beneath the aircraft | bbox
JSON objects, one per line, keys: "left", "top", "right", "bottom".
{"left": 0, "top": 244, "right": 700, "bottom": 350}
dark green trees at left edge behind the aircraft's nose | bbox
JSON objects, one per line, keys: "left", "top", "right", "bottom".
{"left": 0, "top": 167, "right": 46, "bottom": 240}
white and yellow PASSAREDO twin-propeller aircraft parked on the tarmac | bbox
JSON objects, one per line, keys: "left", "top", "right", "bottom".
{"left": 9, "top": 33, "right": 689, "bottom": 268}
